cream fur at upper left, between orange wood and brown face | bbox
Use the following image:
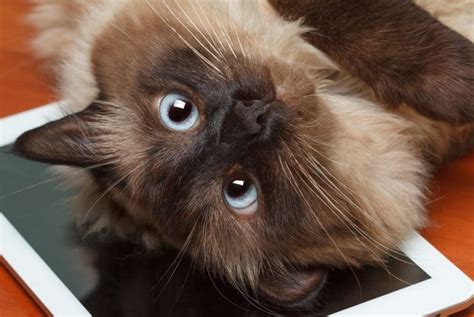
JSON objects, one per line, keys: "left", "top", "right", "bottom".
{"left": 29, "top": 0, "right": 126, "bottom": 113}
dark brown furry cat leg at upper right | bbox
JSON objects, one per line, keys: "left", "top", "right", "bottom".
{"left": 270, "top": 0, "right": 474, "bottom": 124}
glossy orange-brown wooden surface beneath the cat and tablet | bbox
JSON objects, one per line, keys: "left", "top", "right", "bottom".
{"left": 0, "top": 0, "right": 474, "bottom": 316}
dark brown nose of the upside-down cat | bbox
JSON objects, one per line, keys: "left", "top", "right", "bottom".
{"left": 221, "top": 100, "right": 270, "bottom": 143}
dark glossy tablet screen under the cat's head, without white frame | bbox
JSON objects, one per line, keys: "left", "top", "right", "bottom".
{"left": 0, "top": 147, "right": 430, "bottom": 316}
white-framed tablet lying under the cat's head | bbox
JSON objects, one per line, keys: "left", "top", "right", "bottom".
{"left": 0, "top": 104, "right": 473, "bottom": 316}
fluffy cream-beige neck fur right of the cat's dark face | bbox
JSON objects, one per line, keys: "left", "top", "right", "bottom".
{"left": 321, "top": 95, "right": 430, "bottom": 237}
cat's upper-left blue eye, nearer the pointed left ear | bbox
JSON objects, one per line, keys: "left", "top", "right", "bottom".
{"left": 160, "top": 93, "right": 199, "bottom": 131}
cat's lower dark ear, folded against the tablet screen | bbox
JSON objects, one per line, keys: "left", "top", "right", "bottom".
{"left": 258, "top": 268, "right": 328, "bottom": 307}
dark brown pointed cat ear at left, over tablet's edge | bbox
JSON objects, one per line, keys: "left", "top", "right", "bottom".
{"left": 12, "top": 104, "right": 102, "bottom": 167}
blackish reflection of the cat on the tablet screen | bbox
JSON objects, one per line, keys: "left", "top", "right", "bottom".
{"left": 78, "top": 231, "right": 429, "bottom": 317}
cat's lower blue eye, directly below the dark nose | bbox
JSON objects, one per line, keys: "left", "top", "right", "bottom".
{"left": 224, "top": 173, "right": 258, "bottom": 216}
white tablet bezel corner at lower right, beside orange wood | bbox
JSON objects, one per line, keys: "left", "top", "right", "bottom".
{"left": 332, "top": 233, "right": 474, "bottom": 316}
